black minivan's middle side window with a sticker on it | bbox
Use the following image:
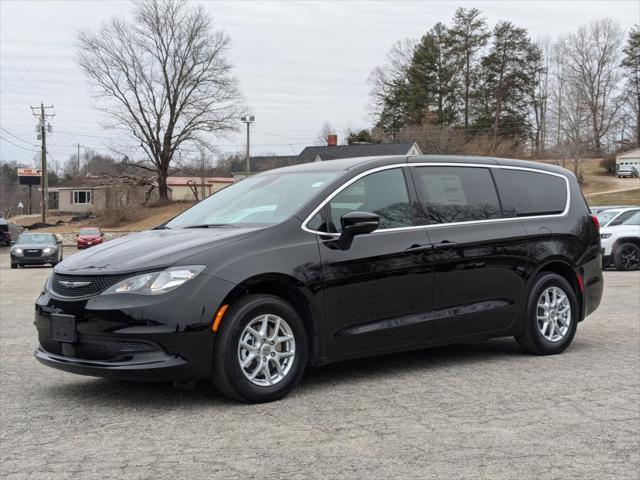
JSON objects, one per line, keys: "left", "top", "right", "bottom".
{"left": 416, "top": 167, "right": 502, "bottom": 223}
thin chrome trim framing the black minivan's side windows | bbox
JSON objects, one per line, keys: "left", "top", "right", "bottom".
{"left": 301, "top": 162, "right": 571, "bottom": 238}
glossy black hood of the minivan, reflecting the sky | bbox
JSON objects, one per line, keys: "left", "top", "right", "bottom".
{"left": 55, "top": 227, "right": 257, "bottom": 274}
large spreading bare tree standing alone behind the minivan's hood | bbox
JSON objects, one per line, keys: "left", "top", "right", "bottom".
{"left": 78, "top": 0, "right": 241, "bottom": 201}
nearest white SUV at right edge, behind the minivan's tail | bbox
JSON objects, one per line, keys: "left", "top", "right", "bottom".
{"left": 600, "top": 209, "right": 640, "bottom": 270}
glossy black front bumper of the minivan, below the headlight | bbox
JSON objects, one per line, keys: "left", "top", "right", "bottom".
{"left": 34, "top": 274, "right": 238, "bottom": 381}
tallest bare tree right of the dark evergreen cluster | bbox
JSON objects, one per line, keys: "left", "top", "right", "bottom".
{"left": 563, "top": 19, "right": 623, "bottom": 151}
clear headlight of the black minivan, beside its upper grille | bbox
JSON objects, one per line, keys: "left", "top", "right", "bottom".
{"left": 102, "top": 265, "right": 205, "bottom": 295}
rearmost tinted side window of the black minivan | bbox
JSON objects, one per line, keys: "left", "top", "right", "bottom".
{"left": 502, "top": 169, "right": 567, "bottom": 217}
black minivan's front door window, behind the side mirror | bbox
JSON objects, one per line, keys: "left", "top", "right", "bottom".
{"left": 329, "top": 168, "right": 411, "bottom": 232}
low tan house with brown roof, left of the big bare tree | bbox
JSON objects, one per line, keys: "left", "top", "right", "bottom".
{"left": 49, "top": 176, "right": 158, "bottom": 213}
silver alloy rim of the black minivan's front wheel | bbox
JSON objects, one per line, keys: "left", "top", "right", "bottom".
{"left": 238, "top": 314, "right": 296, "bottom": 387}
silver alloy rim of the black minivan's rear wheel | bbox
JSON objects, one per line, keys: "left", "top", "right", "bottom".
{"left": 536, "top": 286, "right": 571, "bottom": 342}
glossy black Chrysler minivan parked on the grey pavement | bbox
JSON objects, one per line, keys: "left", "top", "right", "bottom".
{"left": 34, "top": 156, "right": 603, "bottom": 402}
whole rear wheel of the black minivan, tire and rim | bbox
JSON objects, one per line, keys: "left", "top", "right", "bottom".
{"left": 515, "top": 272, "right": 579, "bottom": 355}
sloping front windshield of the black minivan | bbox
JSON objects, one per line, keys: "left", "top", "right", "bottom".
{"left": 166, "top": 171, "right": 338, "bottom": 228}
